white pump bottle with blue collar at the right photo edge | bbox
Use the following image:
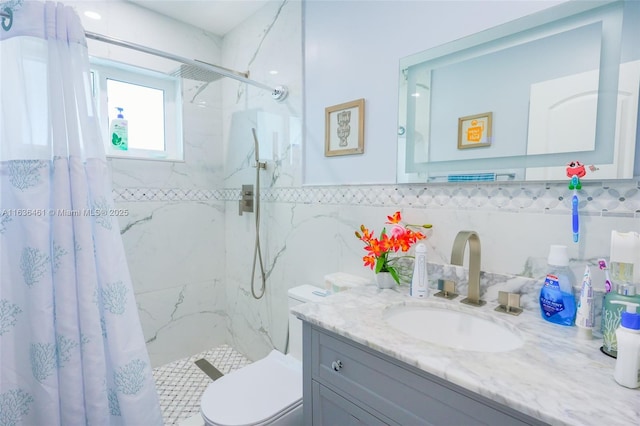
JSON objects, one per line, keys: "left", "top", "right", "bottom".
{"left": 611, "top": 300, "right": 640, "bottom": 389}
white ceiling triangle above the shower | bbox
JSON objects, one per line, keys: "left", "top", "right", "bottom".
{"left": 128, "top": 0, "right": 270, "bottom": 37}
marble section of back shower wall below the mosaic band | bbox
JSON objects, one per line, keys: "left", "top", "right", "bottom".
{"left": 116, "top": 198, "right": 227, "bottom": 367}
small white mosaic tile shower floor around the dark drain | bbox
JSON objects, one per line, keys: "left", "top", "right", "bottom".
{"left": 153, "top": 345, "right": 251, "bottom": 425}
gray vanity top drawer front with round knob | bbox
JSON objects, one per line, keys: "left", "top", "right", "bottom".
{"left": 311, "top": 328, "right": 541, "bottom": 425}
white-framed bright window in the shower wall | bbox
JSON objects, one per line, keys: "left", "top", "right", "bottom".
{"left": 91, "top": 58, "right": 183, "bottom": 161}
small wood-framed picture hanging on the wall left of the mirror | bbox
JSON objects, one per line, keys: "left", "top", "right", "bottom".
{"left": 324, "top": 99, "right": 364, "bottom": 157}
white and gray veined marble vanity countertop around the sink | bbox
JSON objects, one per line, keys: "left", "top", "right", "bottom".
{"left": 291, "top": 286, "right": 640, "bottom": 426}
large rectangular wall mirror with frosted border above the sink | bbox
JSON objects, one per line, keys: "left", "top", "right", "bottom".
{"left": 397, "top": 1, "right": 640, "bottom": 183}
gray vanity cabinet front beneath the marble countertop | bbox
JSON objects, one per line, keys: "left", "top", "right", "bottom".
{"left": 303, "top": 322, "right": 544, "bottom": 426}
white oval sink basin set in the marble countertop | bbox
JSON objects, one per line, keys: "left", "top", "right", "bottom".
{"left": 384, "top": 306, "right": 524, "bottom": 352}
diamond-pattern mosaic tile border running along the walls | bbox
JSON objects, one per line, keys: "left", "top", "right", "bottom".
{"left": 113, "top": 180, "right": 640, "bottom": 218}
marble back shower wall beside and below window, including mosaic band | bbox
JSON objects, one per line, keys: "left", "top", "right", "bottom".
{"left": 102, "top": 46, "right": 227, "bottom": 367}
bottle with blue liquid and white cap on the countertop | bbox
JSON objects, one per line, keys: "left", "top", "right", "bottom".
{"left": 540, "top": 245, "right": 576, "bottom": 326}
